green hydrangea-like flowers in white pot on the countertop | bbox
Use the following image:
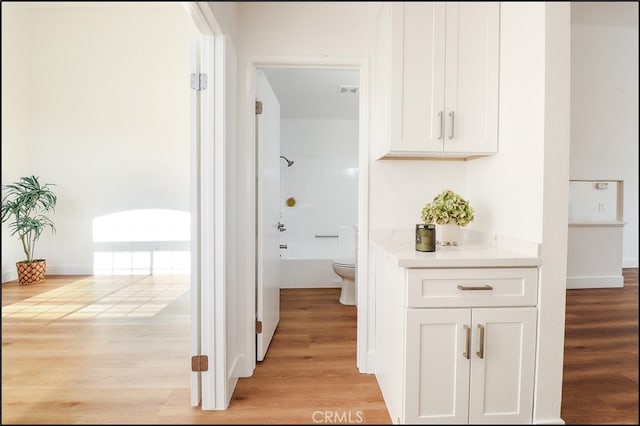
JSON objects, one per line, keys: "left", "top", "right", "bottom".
{"left": 421, "top": 189, "right": 475, "bottom": 246}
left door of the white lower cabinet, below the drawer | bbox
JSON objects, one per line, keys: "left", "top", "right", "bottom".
{"left": 403, "top": 309, "right": 471, "bottom": 424}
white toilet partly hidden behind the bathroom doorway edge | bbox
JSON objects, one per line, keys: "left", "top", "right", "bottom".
{"left": 331, "top": 225, "right": 358, "bottom": 305}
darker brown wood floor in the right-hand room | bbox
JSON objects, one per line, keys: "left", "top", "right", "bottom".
{"left": 561, "top": 268, "right": 638, "bottom": 424}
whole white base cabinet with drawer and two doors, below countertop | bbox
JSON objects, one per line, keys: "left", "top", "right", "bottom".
{"left": 374, "top": 246, "right": 538, "bottom": 424}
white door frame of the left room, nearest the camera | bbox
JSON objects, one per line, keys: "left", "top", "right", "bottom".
{"left": 183, "top": 2, "right": 228, "bottom": 410}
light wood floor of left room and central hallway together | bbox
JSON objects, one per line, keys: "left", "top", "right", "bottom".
{"left": 2, "top": 277, "right": 390, "bottom": 424}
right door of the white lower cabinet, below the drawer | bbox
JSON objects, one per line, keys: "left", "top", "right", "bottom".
{"left": 469, "top": 308, "right": 537, "bottom": 424}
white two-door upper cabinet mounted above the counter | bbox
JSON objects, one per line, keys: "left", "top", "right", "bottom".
{"left": 376, "top": 2, "right": 500, "bottom": 159}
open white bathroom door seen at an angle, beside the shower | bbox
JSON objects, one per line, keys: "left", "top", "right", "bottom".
{"left": 256, "top": 71, "right": 280, "bottom": 361}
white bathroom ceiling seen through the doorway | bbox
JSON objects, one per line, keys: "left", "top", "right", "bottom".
{"left": 263, "top": 68, "right": 360, "bottom": 120}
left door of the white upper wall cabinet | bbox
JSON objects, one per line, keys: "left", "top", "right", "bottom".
{"left": 390, "top": 2, "right": 445, "bottom": 155}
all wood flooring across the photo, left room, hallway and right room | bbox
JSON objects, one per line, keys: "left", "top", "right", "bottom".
{"left": 2, "top": 269, "right": 638, "bottom": 424}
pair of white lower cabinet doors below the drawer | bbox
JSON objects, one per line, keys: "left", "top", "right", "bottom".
{"left": 404, "top": 308, "right": 536, "bottom": 424}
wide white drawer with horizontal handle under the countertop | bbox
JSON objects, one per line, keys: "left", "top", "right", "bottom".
{"left": 407, "top": 268, "right": 538, "bottom": 308}
